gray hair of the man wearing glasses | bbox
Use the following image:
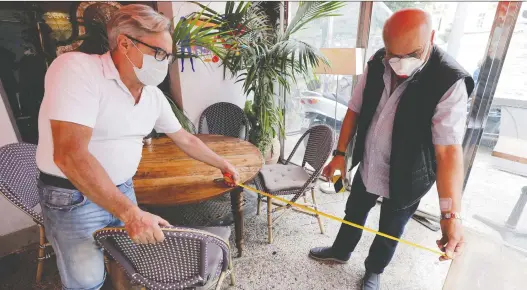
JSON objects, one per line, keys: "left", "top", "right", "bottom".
{"left": 106, "top": 4, "right": 170, "bottom": 50}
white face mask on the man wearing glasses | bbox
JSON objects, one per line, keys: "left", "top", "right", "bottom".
{"left": 125, "top": 42, "right": 168, "bottom": 86}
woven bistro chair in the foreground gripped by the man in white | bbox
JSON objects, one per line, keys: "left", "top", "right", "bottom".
{"left": 94, "top": 227, "right": 235, "bottom": 290}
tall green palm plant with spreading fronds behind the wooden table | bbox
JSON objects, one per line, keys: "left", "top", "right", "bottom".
{"left": 176, "top": 1, "right": 344, "bottom": 153}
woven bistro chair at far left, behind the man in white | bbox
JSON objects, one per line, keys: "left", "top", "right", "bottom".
{"left": 0, "top": 143, "right": 53, "bottom": 283}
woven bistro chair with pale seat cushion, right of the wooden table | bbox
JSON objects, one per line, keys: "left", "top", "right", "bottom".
{"left": 255, "top": 125, "right": 334, "bottom": 243}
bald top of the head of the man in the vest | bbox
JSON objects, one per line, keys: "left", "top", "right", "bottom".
{"left": 383, "top": 9, "right": 434, "bottom": 57}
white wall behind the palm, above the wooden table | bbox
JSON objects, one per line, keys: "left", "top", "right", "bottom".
{"left": 170, "top": 2, "right": 245, "bottom": 125}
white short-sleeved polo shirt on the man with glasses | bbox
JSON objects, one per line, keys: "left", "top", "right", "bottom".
{"left": 37, "top": 52, "right": 181, "bottom": 185}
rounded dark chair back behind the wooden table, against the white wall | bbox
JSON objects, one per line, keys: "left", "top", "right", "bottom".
{"left": 198, "top": 102, "right": 249, "bottom": 140}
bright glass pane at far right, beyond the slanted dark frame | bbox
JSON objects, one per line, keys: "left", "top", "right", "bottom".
{"left": 463, "top": 5, "right": 527, "bottom": 249}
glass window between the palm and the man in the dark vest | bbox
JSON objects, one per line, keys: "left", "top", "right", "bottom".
{"left": 284, "top": 2, "right": 360, "bottom": 164}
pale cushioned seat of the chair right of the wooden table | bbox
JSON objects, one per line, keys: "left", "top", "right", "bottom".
{"left": 260, "top": 164, "right": 310, "bottom": 192}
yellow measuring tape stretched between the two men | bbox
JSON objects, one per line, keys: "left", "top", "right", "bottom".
{"left": 237, "top": 183, "right": 446, "bottom": 256}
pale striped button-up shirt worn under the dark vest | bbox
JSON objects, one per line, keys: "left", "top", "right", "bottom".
{"left": 348, "top": 61, "right": 468, "bottom": 198}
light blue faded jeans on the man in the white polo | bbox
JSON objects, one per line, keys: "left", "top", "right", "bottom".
{"left": 38, "top": 179, "right": 137, "bottom": 290}
